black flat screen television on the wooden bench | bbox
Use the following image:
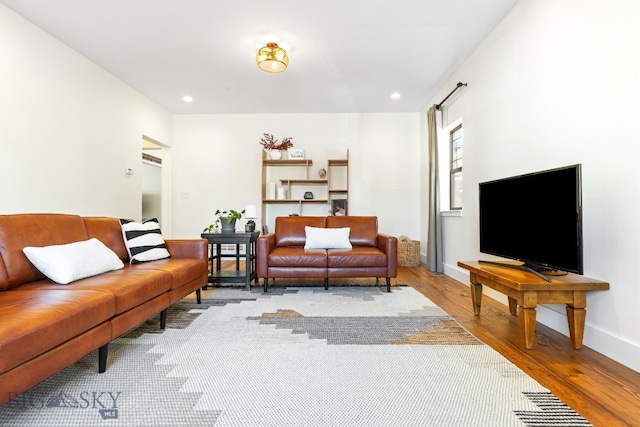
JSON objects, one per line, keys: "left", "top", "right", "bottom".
{"left": 479, "top": 164, "right": 583, "bottom": 281}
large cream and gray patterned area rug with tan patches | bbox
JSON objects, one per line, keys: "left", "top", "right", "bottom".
{"left": 0, "top": 287, "right": 590, "bottom": 427}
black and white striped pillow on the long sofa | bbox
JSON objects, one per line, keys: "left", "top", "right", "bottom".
{"left": 120, "top": 218, "right": 170, "bottom": 264}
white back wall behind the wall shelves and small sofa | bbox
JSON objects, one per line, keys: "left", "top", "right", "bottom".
{"left": 172, "top": 113, "right": 420, "bottom": 239}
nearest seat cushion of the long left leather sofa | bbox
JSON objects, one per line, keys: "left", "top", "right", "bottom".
{"left": 0, "top": 285, "right": 115, "bottom": 373}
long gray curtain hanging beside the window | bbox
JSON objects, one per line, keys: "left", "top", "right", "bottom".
{"left": 427, "top": 105, "right": 444, "bottom": 274}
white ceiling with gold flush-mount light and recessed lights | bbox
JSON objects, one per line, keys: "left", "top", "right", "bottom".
{"left": 0, "top": 0, "right": 517, "bottom": 114}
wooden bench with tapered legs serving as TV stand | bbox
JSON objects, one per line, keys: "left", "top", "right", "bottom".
{"left": 458, "top": 261, "right": 609, "bottom": 349}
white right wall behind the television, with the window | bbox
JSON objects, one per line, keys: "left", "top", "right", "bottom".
{"left": 422, "top": 0, "right": 640, "bottom": 371}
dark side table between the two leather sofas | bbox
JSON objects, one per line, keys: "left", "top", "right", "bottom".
{"left": 200, "top": 231, "right": 260, "bottom": 290}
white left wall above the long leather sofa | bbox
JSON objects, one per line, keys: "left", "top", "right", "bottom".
{"left": 0, "top": 5, "right": 173, "bottom": 224}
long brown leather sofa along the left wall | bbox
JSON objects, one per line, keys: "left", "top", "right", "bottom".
{"left": 0, "top": 214, "right": 207, "bottom": 405}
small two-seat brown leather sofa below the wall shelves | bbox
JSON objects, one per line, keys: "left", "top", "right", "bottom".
{"left": 256, "top": 216, "right": 398, "bottom": 292}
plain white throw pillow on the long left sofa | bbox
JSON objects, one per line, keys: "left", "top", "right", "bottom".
{"left": 22, "top": 238, "right": 124, "bottom": 285}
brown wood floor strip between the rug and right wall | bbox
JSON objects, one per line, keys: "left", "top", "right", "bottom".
{"left": 400, "top": 266, "right": 640, "bottom": 427}
